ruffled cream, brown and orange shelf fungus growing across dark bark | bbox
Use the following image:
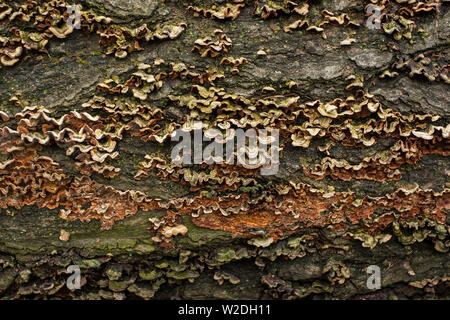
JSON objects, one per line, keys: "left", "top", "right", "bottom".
{"left": 0, "top": 0, "right": 450, "bottom": 299}
